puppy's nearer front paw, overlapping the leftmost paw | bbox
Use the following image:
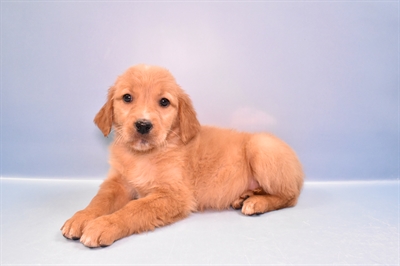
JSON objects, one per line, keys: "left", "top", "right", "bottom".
{"left": 80, "top": 215, "right": 125, "bottom": 248}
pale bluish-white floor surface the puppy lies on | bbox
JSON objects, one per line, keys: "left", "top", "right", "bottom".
{"left": 0, "top": 178, "right": 400, "bottom": 265}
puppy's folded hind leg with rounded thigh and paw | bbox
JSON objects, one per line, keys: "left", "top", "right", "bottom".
{"left": 242, "top": 134, "right": 304, "bottom": 215}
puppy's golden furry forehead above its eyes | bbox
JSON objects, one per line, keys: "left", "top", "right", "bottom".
{"left": 115, "top": 66, "right": 178, "bottom": 94}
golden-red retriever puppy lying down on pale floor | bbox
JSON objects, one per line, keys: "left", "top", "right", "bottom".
{"left": 61, "top": 65, "right": 303, "bottom": 247}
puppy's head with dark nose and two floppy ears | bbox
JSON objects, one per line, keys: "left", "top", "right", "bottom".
{"left": 94, "top": 65, "right": 200, "bottom": 151}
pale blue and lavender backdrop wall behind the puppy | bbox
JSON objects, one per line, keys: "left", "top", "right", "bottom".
{"left": 1, "top": 1, "right": 399, "bottom": 180}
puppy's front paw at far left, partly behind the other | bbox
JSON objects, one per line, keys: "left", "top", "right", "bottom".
{"left": 61, "top": 210, "right": 96, "bottom": 240}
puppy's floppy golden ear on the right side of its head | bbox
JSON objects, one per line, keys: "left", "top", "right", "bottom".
{"left": 178, "top": 92, "right": 200, "bottom": 144}
